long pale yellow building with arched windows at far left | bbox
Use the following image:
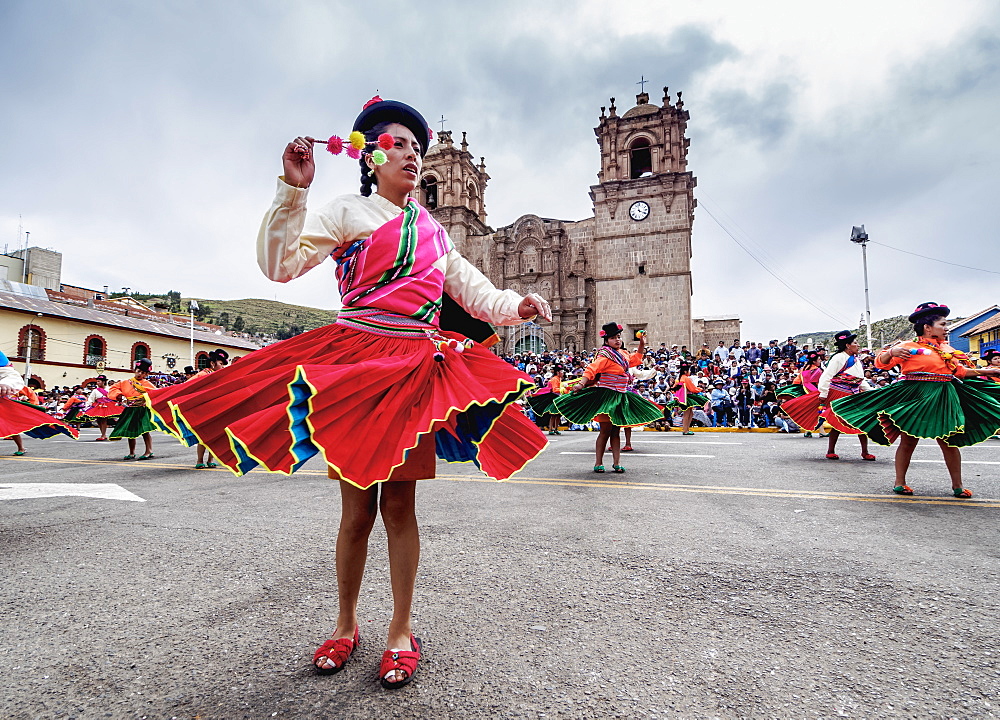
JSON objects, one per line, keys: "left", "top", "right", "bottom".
{"left": 0, "top": 284, "right": 259, "bottom": 387}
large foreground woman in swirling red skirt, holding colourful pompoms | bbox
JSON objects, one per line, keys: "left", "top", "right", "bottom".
{"left": 151, "top": 98, "right": 551, "bottom": 688}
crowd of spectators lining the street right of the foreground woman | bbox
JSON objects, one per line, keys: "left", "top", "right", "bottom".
{"left": 503, "top": 338, "right": 898, "bottom": 432}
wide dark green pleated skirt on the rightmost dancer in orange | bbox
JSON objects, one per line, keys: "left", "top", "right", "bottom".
{"left": 830, "top": 378, "right": 1000, "bottom": 447}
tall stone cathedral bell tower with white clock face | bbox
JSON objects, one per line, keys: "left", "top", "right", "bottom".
{"left": 588, "top": 88, "right": 697, "bottom": 347}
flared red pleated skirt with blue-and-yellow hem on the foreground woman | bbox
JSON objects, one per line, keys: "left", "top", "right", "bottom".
{"left": 149, "top": 324, "right": 546, "bottom": 488}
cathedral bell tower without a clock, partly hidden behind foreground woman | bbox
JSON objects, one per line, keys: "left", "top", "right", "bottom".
{"left": 416, "top": 130, "right": 493, "bottom": 272}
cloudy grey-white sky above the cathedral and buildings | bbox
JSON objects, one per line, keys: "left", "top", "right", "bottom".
{"left": 0, "top": 0, "right": 1000, "bottom": 339}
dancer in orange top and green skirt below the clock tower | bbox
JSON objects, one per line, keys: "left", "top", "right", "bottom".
{"left": 555, "top": 323, "right": 663, "bottom": 473}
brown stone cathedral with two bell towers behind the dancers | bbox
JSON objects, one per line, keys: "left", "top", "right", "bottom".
{"left": 417, "top": 88, "right": 740, "bottom": 351}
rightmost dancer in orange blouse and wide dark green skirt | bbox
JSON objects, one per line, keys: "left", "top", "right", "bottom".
{"left": 830, "top": 302, "right": 1000, "bottom": 498}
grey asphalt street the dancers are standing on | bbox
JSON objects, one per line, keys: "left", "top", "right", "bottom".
{"left": 0, "top": 430, "right": 1000, "bottom": 719}
